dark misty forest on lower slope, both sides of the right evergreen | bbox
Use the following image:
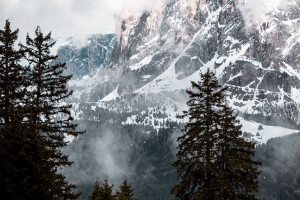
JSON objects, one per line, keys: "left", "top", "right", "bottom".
{"left": 64, "top": 109, "right": 300, "bottom": 200}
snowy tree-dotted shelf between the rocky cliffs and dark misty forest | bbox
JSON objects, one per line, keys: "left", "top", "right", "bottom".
{"left": 68, "top": 88, "right": 299, "bottom": 143}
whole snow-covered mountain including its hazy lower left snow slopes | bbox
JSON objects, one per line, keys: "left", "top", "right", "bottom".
{"left": 62, "top": 0, "right": 300, "bottom": 140}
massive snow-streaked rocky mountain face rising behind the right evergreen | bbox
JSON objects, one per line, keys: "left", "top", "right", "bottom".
{"left": 103, "top": 0, "right": 300, "bottom": 123}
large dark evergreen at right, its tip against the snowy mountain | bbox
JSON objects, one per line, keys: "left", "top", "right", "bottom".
{"left": 171, "top": 70, "right": 259, "bottom": 200}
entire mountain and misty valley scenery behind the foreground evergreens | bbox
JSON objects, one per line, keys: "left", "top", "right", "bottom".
{"left": 53, "top": 0, "right": 300, "bottom": 200}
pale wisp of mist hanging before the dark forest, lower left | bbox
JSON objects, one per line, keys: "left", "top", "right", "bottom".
{"left": 62, "top": 123, "right": 134, "bottom": 189}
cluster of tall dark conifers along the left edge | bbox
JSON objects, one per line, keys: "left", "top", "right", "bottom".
{"left": 0, "top": 20, "right": 82, "bottom": 199}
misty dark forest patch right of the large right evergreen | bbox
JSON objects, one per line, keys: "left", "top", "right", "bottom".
{"left": 255, "top": 133, "right": 300, "bottom": 200}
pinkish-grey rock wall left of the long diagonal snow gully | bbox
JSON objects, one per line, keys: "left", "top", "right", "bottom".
{"left": 110, "top": 0, "right": 208, "bottom": 94}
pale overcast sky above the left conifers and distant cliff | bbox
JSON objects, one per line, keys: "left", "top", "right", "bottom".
{"left": 0, "top": 0, "right": 158, "bottom": 41}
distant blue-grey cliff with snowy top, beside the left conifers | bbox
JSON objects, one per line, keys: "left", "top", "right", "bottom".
{"left": 55, "top": 34, "right": 116, "bottom": 79}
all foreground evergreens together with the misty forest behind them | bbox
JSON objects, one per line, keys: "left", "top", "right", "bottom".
{"left": 0, "top": 20, "right": 300, "bottom": 200}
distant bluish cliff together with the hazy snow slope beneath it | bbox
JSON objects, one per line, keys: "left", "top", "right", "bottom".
{"left": 51, "top": 34, "right": 117, "bottom": 103}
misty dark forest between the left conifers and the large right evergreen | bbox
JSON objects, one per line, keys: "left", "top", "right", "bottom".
{"left": 64, "top": 121, "right": 181, "bottom": 200}
